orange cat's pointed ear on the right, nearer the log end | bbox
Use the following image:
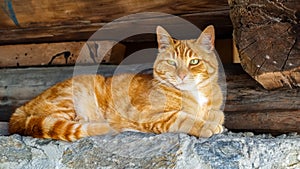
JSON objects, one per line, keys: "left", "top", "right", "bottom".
{"left": 196, "top": 25, "right": 215, "bottom": 52}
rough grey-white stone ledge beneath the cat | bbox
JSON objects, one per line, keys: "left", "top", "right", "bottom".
{"left": 0, "top": 132, "right": 300, "bottom": 169}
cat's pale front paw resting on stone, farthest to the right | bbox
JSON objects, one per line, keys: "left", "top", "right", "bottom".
{"left": 199, "top": 122, "right": 224, "bottom": 138}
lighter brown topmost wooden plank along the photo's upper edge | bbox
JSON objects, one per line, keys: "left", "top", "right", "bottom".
{"left": 0, "top": 0, "right": 229, "bottom": 29}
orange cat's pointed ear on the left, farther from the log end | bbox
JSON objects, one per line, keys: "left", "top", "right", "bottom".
{"left": 156, "top": 26, "right": 173, "bottom": 52}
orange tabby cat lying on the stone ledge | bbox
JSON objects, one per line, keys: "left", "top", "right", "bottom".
{"left": 9, "top": 26, "right": 224, "bottom": 141}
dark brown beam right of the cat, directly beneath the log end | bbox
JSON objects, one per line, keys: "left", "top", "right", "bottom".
{"left": 225, "top": 67, "right": 300, "bottom": 113}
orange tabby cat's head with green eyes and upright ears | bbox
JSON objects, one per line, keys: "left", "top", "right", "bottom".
{"left": 153, "top": 26, "right": 218, "bottom": 90}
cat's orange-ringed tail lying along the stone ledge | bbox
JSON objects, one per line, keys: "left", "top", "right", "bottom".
{"left": 9, "top": 108, "right": 115, "bottom": 141}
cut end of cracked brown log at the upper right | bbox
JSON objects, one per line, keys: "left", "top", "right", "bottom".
{"left": 228, "top": 0, "right": 300, "bottom": 89}
